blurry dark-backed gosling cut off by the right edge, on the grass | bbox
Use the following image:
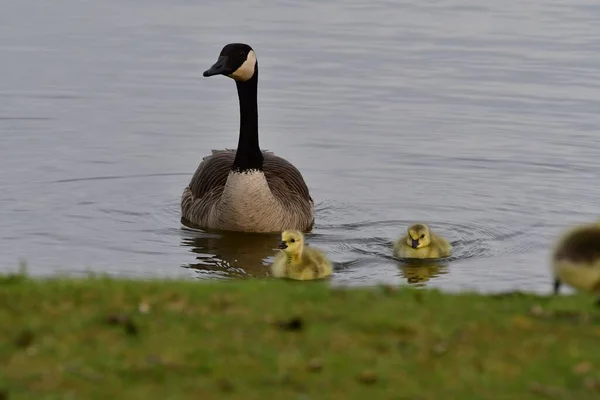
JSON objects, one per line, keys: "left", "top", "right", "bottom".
{"left": 552, "top": 221, "right": 600, "bottom": 305}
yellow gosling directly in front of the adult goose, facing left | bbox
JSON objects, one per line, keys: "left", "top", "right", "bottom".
{"left": 271, "top": 231, "right": 332, "bottom": 280}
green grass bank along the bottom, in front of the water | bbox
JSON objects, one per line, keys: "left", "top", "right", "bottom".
{"left": 0, "top": 276, "right": 600, "bottom": 400}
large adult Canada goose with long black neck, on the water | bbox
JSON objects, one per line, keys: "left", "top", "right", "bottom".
{"left": 181, "top": 43, "right": 314, "bottom": 232}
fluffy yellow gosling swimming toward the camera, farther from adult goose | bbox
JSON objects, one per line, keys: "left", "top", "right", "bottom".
{"left": 394, "top": 224, "right": 452, "bottom": 258}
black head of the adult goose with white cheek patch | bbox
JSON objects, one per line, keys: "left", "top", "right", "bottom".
{"left": 203, "top": 43, "right": 258, "bottom": 82}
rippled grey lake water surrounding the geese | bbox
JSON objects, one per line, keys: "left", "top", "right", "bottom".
{"left": 0, "top": 0, "right": 600, "bottom": 293}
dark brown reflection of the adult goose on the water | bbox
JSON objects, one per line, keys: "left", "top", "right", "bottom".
{"left": 181, "top": 225, "right": 279, "bottom": 277}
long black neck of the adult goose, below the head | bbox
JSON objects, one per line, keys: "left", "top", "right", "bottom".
{"left": 232, "top": 68, "right": 263, "bottom": 172}
